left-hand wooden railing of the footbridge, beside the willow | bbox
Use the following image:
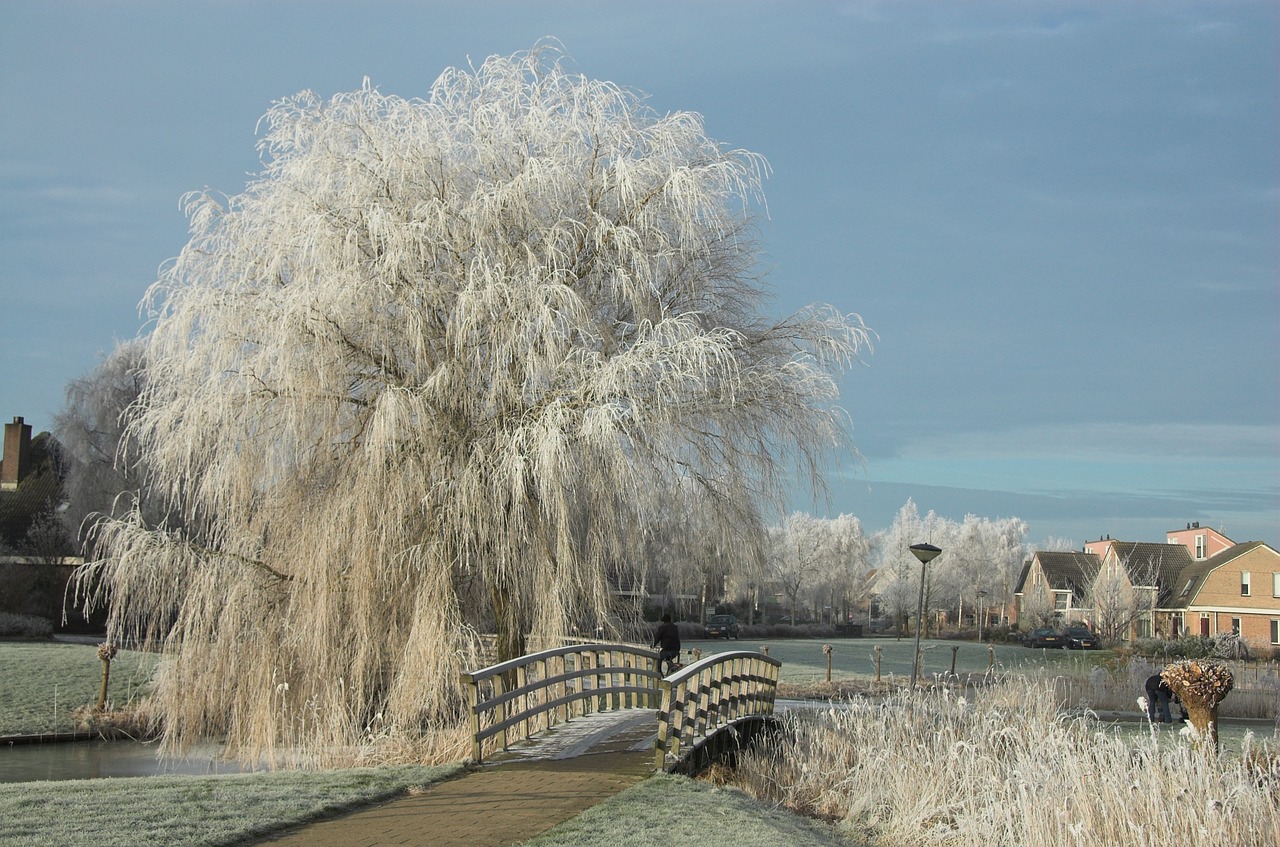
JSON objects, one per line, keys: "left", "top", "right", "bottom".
{"left": 462, "top": 644, "right": 662, "bottom": 761}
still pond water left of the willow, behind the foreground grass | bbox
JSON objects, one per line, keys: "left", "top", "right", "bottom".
{"left": 0, "top": 741, "right": 252, "bottom": 782}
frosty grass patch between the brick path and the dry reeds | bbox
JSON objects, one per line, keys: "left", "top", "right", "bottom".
{"left": 524, "top": 775, "right": 852, "bottom": 847}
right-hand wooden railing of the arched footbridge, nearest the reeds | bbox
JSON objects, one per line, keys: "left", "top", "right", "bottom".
{"left": 654, "top": 650, "right": 782, "bottom": 770}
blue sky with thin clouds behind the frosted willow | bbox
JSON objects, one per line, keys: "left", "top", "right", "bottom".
{"left": 0, "top": 0, "right": 1280, "bottom": 545}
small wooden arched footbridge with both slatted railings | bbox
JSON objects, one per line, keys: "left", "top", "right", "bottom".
{"left": 462, "top": 644, "right": 782, "bottom": 770}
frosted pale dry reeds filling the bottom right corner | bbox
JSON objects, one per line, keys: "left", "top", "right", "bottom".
{"left": 735, "top": 679, "right": 1280, "bottom": 847}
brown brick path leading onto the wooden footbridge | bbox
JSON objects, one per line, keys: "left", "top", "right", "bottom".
{"left": 259, "top": 710, "right": 654, "bottom": 847}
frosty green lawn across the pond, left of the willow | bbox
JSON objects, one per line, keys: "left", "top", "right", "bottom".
{"left": 0, "top": 641, "right": 157, "bottom": 736}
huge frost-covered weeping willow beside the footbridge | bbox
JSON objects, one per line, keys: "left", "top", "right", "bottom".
{"left": 80, "top": 47, "right": 868, "bottom": 756}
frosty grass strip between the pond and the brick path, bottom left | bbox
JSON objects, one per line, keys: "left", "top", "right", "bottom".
{"left": 0, "top": 754, "right": 461, "bottom": 847}
